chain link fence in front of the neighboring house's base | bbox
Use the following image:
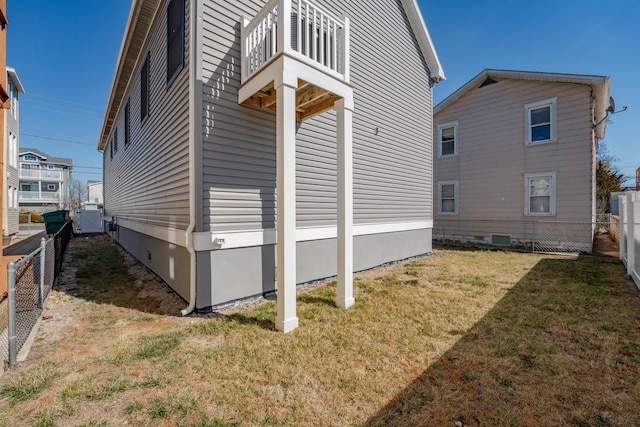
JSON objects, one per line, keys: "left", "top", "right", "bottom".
{"left": 433, "top": 221, "right": 610, "bottom": 253}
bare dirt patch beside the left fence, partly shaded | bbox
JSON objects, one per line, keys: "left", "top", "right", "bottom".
{"left": 19, "top": 234, "right": 198, "bottom": 369}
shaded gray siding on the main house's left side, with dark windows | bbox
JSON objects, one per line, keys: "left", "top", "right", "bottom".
{"left": 104, "top": 0, "right": 190, "bottom": 229}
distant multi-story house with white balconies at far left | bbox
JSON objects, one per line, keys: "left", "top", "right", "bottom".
{"left": 19, "top": 148, "right": 73, "bottom": 213}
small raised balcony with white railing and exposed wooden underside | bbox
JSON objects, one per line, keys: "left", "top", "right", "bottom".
{"left": 238, "top": 0, "right": 350, "bottom": 121}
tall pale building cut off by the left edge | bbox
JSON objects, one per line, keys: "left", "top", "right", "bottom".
{"left": 2, "top": 67, "right": 24, "bottom": 236}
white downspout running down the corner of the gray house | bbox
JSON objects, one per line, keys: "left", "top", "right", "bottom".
{"left": 181, "top": 0, "right": 202, "bottom": 316}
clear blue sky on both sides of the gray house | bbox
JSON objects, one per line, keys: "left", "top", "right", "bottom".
{"left": 7, "top": 0, "right": 640, "bottom": 186}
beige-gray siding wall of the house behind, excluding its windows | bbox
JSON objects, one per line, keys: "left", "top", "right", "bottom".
{"left": 434, "top": 79, "right": 594, "bottom": 237}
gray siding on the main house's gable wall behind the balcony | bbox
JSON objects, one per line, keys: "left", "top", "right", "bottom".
{"left": 202, "top": 0, "right": 433, "bottom": 231}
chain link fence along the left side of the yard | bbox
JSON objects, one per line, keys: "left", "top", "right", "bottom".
{"left": 0, "top": 222, "right": 72, "bottom": 368}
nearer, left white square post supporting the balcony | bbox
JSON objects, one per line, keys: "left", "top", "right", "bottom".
{"left": 275, "top": 77, "right": 298, "bottom": 333}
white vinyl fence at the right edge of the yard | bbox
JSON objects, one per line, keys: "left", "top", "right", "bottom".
{"left": 618, "top": 191, "right": 640, "bottom": 288}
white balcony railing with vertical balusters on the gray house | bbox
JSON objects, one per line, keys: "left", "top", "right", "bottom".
{"left": 241, "top": 0, "right": 349, "bottom": 83}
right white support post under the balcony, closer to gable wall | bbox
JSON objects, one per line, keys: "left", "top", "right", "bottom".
{"left": 334, "top": 98, "right": 354, "bottom": 308}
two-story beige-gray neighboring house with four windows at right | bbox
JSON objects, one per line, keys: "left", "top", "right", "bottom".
{"left": 433, "top": 70, "right": 610, "bottom": 252}
